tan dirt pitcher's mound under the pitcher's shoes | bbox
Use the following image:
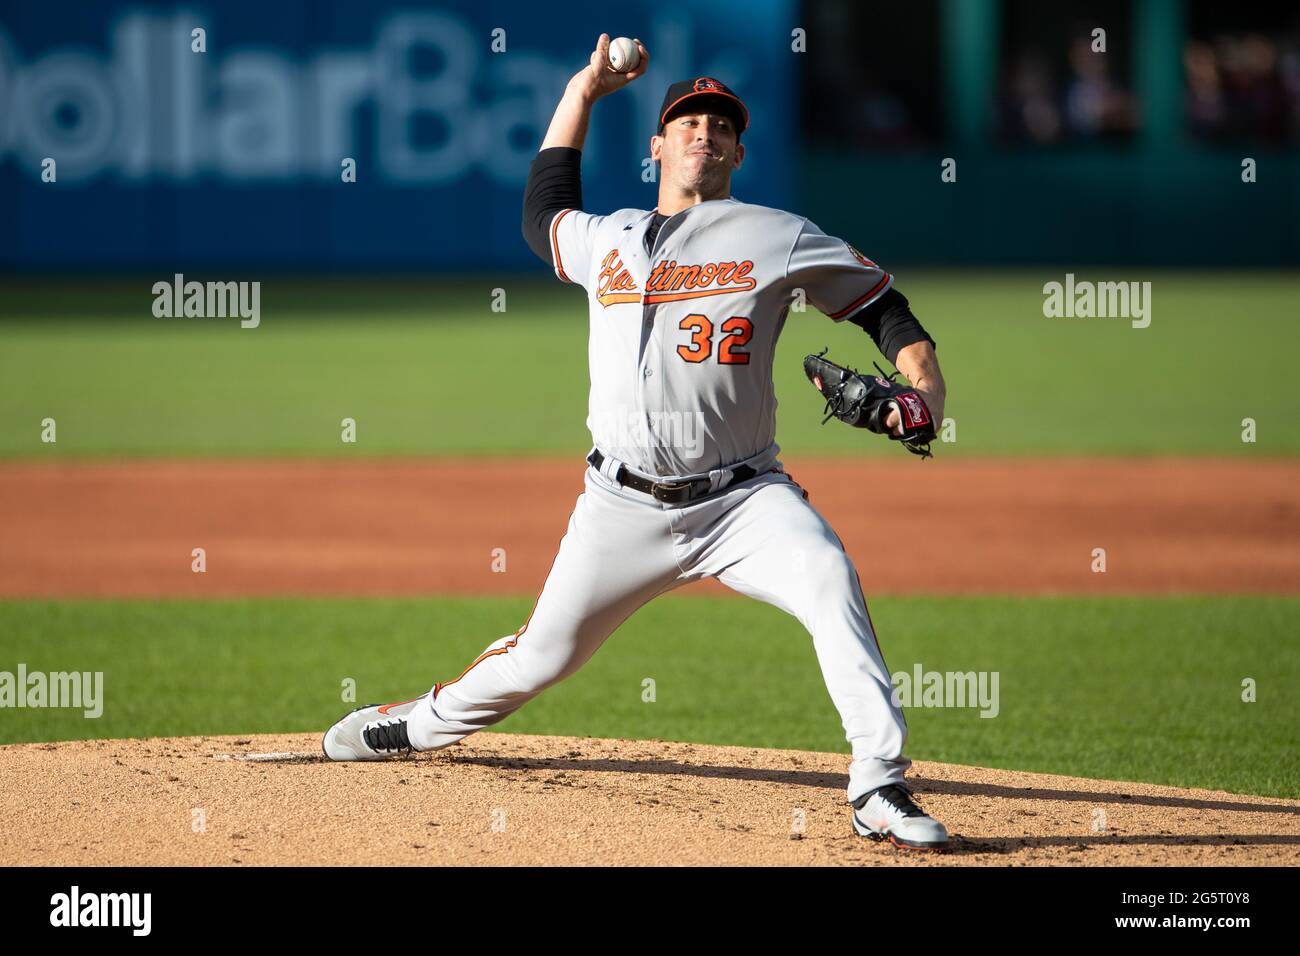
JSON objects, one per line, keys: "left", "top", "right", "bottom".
{"left": 0, "top": 734, "right": 1300, "bottom": 866}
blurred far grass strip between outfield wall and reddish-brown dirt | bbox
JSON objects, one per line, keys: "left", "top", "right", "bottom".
{"left": 0, "top": 269, "right": 1300, "bottom": 459}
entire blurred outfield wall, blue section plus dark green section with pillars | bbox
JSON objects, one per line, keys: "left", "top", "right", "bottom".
{"left": 0, "top": 0, "right": 1300, "bottom": 270}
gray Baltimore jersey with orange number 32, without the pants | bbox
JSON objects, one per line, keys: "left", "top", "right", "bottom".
{"left": 550, "top": 198, "right": 893, "bottom": 477}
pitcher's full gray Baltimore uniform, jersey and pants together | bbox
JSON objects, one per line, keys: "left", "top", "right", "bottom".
{"left": 397, "top": 199, "right": 911, "bottom": 816}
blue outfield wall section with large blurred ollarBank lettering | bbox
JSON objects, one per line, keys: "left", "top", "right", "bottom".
{"left": 0, "top": 0, "right": 797, "bottom": 273}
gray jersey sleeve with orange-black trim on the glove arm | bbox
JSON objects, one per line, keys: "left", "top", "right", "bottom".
{"left": 785, "top": 220, "right": 893, "bottom": 321}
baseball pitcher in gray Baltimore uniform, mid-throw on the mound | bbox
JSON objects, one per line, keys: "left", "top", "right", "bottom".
{"left": 324, "top": 34, "right": 948, "bottom": 849}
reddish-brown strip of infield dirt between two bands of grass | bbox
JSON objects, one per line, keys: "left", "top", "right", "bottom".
{"left": 0, "top": 454, "right": 1300, "bottom": 597}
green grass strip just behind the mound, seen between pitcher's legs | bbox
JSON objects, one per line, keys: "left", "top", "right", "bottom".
{"left": 0, "top": 597, "right": 1300, "bottom": 797}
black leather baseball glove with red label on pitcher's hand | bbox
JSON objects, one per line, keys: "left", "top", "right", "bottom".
{"left": 803, "top": 349, "right": 935, "bottom": 458}
